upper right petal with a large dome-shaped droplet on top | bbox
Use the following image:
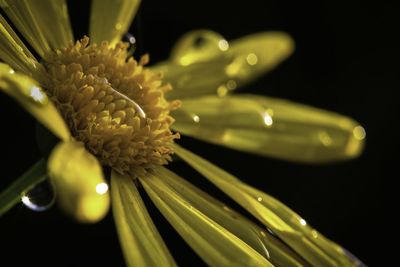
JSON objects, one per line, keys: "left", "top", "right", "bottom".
{"left": 153, "top": 30, "right": 294, "bottom": 99}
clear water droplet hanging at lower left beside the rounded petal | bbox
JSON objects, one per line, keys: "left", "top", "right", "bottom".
{"left": 21, "top": 180, "right": 55, "bottom": 211}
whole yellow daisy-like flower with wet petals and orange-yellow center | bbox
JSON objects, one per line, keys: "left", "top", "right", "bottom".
{"left": 0, "top": 0, "right": 365, "bottom": 266}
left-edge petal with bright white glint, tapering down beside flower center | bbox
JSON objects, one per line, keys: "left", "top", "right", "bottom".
{"left": 0, "top": 63, "right": 70, "bottom": 140}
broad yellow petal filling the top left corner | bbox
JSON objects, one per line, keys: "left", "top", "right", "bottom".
{"left": 1, "top": 0, "right": 73, "bottom": 57}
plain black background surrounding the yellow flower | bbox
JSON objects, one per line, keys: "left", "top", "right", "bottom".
{"left": 0, "top": 0, "right": 398, "bottom": 266}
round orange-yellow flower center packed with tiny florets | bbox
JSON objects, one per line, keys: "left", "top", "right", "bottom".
{"left": 44, "top": 37, "right": 179, "bottom": 175}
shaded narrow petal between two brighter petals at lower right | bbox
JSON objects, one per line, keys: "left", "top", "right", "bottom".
{"left": 155, "top": 167, "right": 307, "bottom": 266}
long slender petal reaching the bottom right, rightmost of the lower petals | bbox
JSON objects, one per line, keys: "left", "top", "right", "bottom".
{"left": 174, "top": 145, "right": 355, "bottom": 266}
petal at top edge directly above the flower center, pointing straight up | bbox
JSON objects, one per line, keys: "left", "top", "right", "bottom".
{"left": 89, "top": 0, "right": 140, "bottom": 45}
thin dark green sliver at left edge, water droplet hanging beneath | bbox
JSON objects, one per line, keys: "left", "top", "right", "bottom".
{"left": 0, "top": 159, "right": 47, "bottom": 216}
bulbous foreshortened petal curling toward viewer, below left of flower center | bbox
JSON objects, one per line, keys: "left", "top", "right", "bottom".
{"left": 48, "top": 141, "right": 110, "bottom": 223}
